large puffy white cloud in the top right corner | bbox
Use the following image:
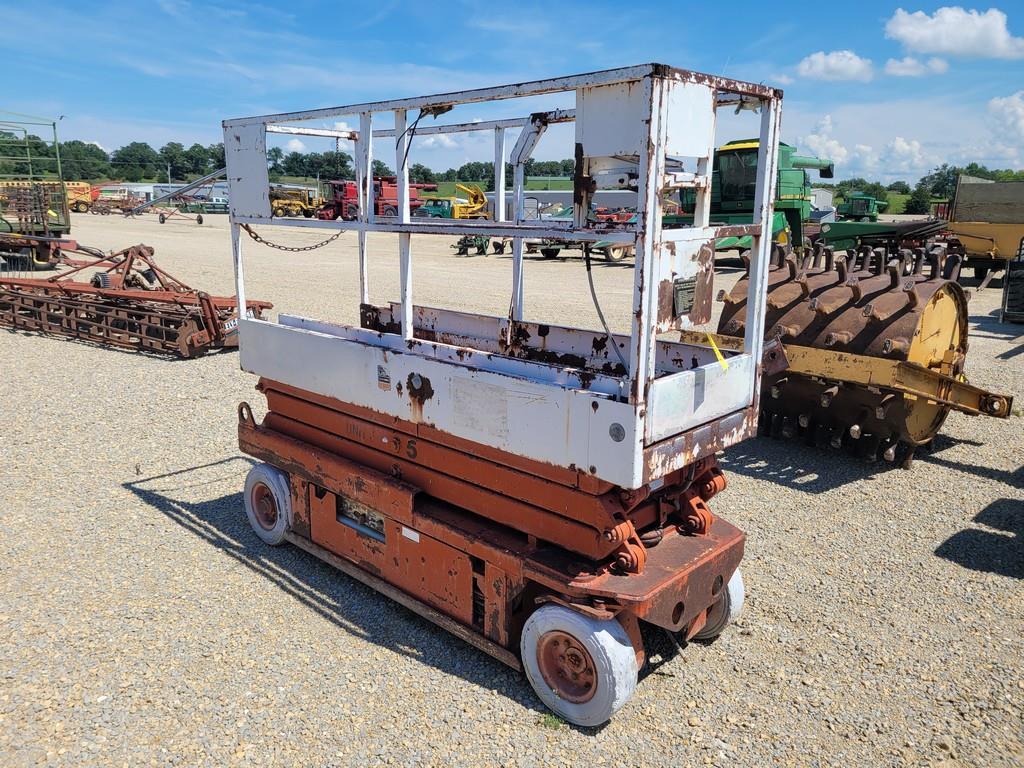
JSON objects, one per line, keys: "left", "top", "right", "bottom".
{"left": 886, "top": 5, "right": 1024, "bottom": 58}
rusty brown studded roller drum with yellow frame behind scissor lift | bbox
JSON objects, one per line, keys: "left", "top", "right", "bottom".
{"left": 719, "top": 244, "right": 1013, "bottom": 466}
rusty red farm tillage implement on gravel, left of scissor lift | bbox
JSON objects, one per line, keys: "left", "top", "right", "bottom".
{"left": 0, "top": 245, "right": 272, "bottom": 357}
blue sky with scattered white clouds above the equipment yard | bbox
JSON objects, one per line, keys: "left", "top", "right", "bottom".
{"left": 8, "top": 0, "right": 1024, "bottom": 180}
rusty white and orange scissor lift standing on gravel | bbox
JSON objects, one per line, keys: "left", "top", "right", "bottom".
{"left": 224, "top": 65, "right": 781, "bottom": 725}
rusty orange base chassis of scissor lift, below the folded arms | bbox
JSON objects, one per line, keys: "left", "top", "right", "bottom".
{"left": 239, "top": 382, "right": 745, "bottom": 669}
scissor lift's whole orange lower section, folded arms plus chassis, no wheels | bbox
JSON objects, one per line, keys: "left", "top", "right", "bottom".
{"left": 239, "top": 379, "right": 744, "bottom": 668}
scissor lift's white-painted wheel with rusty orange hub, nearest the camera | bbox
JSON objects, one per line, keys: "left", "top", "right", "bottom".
{"left": 519, "top": 604, "right": 638, "bottom": 726}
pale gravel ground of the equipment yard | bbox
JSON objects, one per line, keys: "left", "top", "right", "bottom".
{"left": 0, "top": 216, "right": 1024, "bottom": 766}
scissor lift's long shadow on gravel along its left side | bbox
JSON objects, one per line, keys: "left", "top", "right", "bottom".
{"left": 123, "top": 457, "right": 622, "bottom": 735}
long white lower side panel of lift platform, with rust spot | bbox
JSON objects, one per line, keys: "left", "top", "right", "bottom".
{"left": 240, "top": 319, "right": 637, "bottom": 487}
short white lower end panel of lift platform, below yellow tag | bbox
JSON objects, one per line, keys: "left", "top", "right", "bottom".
{"left": 644, "top": 354, "right": 755, "bottom": 445}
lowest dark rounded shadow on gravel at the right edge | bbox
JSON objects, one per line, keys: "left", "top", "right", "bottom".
{"left": 935, "top": 499, "right": 1024, "bottom": 579}
